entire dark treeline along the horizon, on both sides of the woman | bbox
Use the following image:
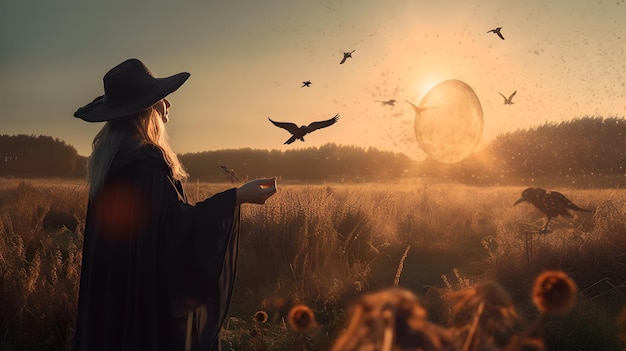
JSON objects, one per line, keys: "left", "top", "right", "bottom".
{"left": 0, "top": 116, "right": 626, "bottom": 186}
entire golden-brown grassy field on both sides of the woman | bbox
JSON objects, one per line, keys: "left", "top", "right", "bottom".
{"left": 0, "top": 179, "right": 626, "bottom": 350}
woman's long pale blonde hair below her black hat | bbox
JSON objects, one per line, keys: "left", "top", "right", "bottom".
{"left": 87, "top": 107, "right": 189, "bottom": 198}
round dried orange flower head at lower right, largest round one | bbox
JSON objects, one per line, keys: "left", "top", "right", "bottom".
{"left": 532, "top": 271, "right": 577, "bottom": 314}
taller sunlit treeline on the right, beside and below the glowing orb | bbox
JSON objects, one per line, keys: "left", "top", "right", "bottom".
{"left": 420, "top": 116, "right": 626, "bottom": 186}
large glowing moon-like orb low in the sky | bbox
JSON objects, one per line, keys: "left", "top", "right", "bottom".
{"left": 407, "top": 79, "right": 483, "bottom": 163}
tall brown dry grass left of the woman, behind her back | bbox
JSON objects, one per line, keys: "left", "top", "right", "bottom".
{"left": 0, "top": 182, "right": 86, "bottom": 350}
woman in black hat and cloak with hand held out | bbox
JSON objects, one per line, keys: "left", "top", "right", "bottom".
{"left": 74, "top": 59, "right": 276, "bottom": 351}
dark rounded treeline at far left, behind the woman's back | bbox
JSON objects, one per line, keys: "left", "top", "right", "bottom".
{"left": 0, "top": 135, "right": 87, "bottom": 177}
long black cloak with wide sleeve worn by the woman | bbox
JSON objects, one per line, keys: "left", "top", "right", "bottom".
{"left": 75, "top": 146, "right": 239, "bottom": 351}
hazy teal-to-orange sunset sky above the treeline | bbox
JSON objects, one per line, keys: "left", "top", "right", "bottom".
{"left": 0, "top": 0, "right": 626, "bottom": 158}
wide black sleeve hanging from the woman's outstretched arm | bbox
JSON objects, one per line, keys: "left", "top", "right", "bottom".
{"left": 167, "top": 180, "right": 239, "bottom": 350}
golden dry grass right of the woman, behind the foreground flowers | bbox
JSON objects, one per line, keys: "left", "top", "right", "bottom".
{"left": 222, "top": 182, "right": 626, "bottom": 350}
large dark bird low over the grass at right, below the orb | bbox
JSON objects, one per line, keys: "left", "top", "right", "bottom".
{"left": 513, "top": 188, "right": 593, "bottom": 233}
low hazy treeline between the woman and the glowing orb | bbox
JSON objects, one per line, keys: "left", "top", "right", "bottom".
{"left": 181, "top": 144, "right": 417, "bottom": 182}
